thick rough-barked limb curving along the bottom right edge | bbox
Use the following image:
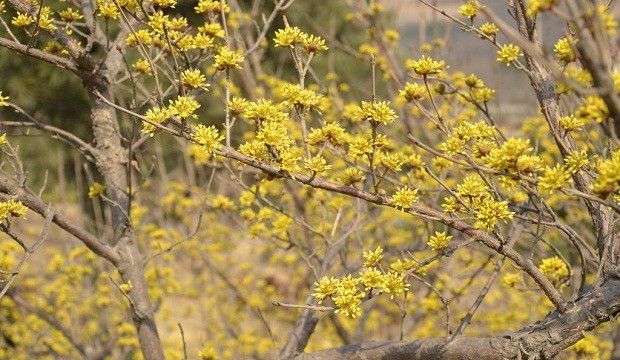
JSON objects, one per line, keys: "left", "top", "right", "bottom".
{"left": 295, "top": 277, "right": 620, "bottom": 360}
